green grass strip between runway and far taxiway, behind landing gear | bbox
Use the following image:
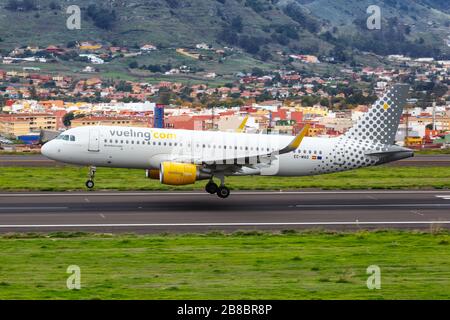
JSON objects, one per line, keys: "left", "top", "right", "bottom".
{"left": 0, "top": 166, "right": 450, "bottom": 191}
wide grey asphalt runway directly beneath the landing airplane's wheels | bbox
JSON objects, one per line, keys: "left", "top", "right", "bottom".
{"left": 0, "top": 191, "right": 450, "bottom": 233}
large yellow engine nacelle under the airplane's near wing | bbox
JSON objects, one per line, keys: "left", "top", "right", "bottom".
{"left": 159, "top": 162, "right": 211, "bottom": 186}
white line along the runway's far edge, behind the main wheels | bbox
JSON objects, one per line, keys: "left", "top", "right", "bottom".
{"left": 0, "top": 190, "right": 450, "bottom": 198}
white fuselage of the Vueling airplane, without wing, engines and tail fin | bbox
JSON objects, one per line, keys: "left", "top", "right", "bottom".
{"left": 42, "top": 126, "right": 394, "bottom": 176}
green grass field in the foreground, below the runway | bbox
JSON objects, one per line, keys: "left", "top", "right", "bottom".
{"left": 0, "top": 231, "right": 450, "bottom": 299}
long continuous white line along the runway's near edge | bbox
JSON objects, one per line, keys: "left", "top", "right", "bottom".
{"left": 0, "top": 221, "right": 450, "bottom": 229}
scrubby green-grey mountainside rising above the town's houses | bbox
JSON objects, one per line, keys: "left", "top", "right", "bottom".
{"left": 0, "top": 0, "right": 450, "bottom": 61}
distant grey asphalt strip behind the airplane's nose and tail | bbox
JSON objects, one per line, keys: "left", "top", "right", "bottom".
{"left": 0, "top": 154, "right": 450, "bottom": 167}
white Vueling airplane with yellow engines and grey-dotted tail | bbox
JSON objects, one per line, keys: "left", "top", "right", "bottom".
{"left": 41, "top": 84, "right": 414, "bottom": 198}
